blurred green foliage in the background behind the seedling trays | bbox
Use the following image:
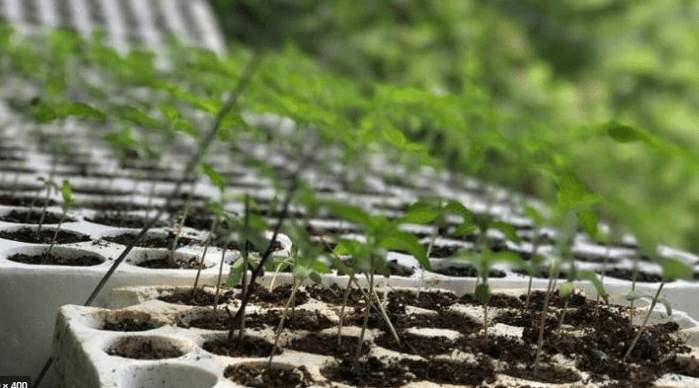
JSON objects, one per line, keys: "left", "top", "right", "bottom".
{"left": 211, "top": 0, "right": 699, "bottom": 252}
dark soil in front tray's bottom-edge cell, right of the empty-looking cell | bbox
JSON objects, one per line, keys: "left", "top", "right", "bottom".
{"left": 223, "top": 365, "right": 313, "bottom": 388}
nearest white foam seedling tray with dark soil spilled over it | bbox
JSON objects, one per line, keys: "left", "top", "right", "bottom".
{"left": 54, "top": 283, "right": 699, "bottom": 388}
